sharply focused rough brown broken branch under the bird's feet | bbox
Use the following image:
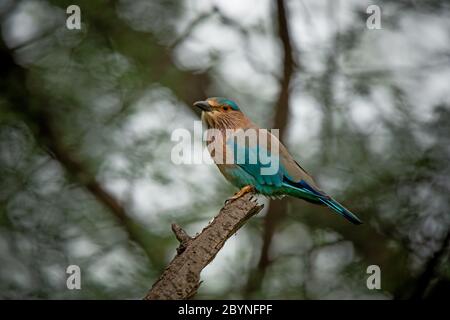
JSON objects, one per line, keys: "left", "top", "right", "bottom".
{"left": 144, "top": 193, "right": 263, "bottom": 300}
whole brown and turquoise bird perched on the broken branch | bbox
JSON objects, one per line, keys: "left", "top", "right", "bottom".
{"left": 194, "top": 97, "right": 362, "bottom": 224}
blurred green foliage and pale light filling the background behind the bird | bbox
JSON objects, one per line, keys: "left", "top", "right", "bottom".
{"left": 0, "top": 0, "right": 450, "bottom": 299}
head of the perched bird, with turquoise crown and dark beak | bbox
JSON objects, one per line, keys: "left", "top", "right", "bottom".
{"left": 194, "top": 97, "right": 245, "bottom": 129}
